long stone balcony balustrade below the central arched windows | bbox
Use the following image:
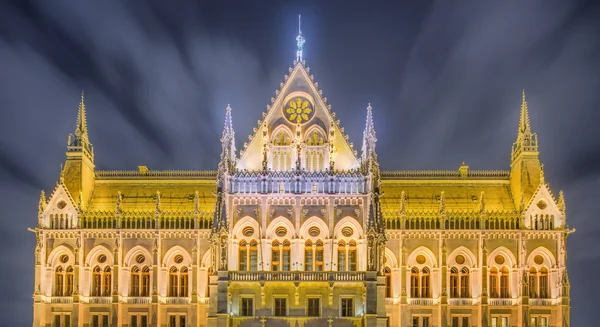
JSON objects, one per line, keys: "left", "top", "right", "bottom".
{"left": 229, "top": 271, "right": 366, "bottom": 282}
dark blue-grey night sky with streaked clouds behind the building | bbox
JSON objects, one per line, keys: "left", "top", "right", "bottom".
{"left": 0, "top": 0, "right": 600, "bottom": 327}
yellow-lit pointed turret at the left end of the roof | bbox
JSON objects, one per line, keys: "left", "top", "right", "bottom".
{"left": 61, "top": 91, "right": 95, "bottom": 209}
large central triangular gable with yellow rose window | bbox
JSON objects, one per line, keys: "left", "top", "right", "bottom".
{"left": 236, "top": 62, "right": 360, "bottom": 171}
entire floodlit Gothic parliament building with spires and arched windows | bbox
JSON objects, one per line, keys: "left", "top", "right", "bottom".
{"left": 31, "top": 26, "right": 573, "bottom": 327}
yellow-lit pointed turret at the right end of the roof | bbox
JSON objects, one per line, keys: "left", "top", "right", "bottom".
{"left": 510, "top": 91, "right": 543, "bottom": 210}
